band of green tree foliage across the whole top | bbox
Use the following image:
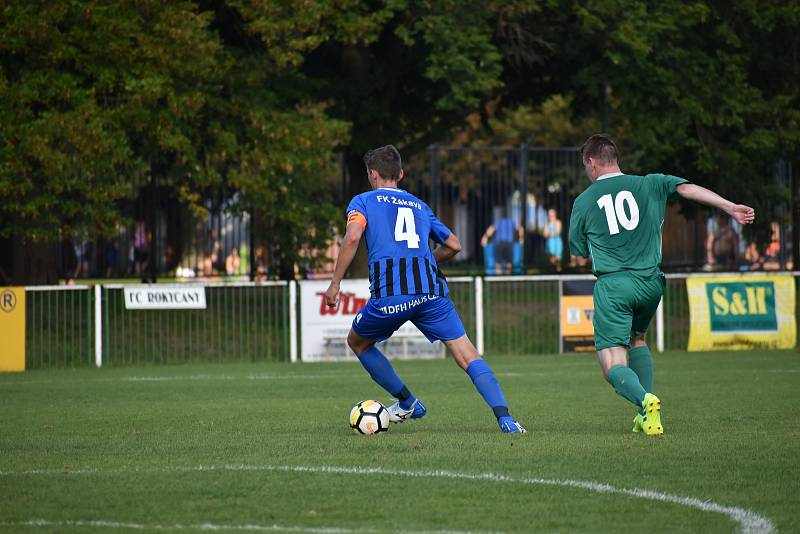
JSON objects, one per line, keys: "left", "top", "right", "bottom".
{"left": 0, "top": 0, "right": 800, "bottom": 268}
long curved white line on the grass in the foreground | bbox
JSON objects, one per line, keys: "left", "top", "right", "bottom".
{"left": 0, "top": 464, "right": 776, "bottom": 534}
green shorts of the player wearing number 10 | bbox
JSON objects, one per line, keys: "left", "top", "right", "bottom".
{"left": 592, "top": 272, "right": 666, "bottom": 350}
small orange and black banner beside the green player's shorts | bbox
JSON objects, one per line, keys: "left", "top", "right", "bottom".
{"left": 559, "top": 280, "right": 594, "bottom": 353}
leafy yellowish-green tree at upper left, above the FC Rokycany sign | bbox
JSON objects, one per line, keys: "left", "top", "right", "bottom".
{"left": 0, "top": 0, "right": 347, "bottom": 282}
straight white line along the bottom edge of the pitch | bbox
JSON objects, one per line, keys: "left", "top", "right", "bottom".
{"left": 0, "top": 519, "right": 494, "bottom": 534}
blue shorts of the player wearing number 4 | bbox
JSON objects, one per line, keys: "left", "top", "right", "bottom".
{"left": 353, "top": 295, "right": 466, "bottom": 343}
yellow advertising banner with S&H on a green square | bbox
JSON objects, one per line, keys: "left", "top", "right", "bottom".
{"left": 686, "top": 274, "right": 797, "bottom": 351}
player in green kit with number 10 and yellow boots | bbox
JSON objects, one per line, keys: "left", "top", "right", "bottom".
{"left": 569, "top": 134, "right": 755, "bottom": 435}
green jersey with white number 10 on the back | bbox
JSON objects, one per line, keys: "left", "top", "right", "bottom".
{"left": 569, "top": 174, "right": 687, "bottom": 277}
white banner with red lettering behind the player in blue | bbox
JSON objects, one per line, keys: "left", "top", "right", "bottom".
{"left": 299, "top": 279, "right": 445, "bottom": 361}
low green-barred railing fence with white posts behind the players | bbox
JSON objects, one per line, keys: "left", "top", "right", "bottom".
{"left": 21, "top": 272, "right": 800, "bottom": 369}
